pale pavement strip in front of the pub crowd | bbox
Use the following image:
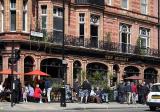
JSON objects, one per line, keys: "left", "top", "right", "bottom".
{"left": 0, "top": 102, "right": 148, "bottom": 112}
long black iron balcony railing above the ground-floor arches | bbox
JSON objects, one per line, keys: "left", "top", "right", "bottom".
{"left": 31, "top": 33, "right": 160, "bottom": 57}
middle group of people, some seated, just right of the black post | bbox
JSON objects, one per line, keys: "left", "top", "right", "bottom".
{"left": 73, "top": 79, "right": 108, "bottom": 103}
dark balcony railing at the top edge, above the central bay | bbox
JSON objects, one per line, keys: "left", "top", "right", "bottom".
{"left": 75, "top": 0, "right": 104, "bottom": 6}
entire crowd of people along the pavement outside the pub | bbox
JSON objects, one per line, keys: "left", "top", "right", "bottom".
{"left": 0, "top": 77, "right": 152, "bottom": 104}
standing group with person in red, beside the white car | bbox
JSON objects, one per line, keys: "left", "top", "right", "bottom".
{"left": 117, "top": 81, "right": 152, "bottom": 104}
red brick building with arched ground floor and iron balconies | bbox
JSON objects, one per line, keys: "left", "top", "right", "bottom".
{"left": 0, "top": 0, "right": 160, "bottom": 85}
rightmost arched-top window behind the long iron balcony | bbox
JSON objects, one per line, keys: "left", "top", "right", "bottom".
{"left": 139, "top": 27, "right": 150, "bottom": 48}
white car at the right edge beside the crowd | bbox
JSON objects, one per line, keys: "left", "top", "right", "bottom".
{"left": 147, "top": 83, "right": 160, "bottom": 111}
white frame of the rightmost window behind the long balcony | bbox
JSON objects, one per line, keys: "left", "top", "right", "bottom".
{"left": 139, "top": 27, "right": 150, "bottom": 49}
